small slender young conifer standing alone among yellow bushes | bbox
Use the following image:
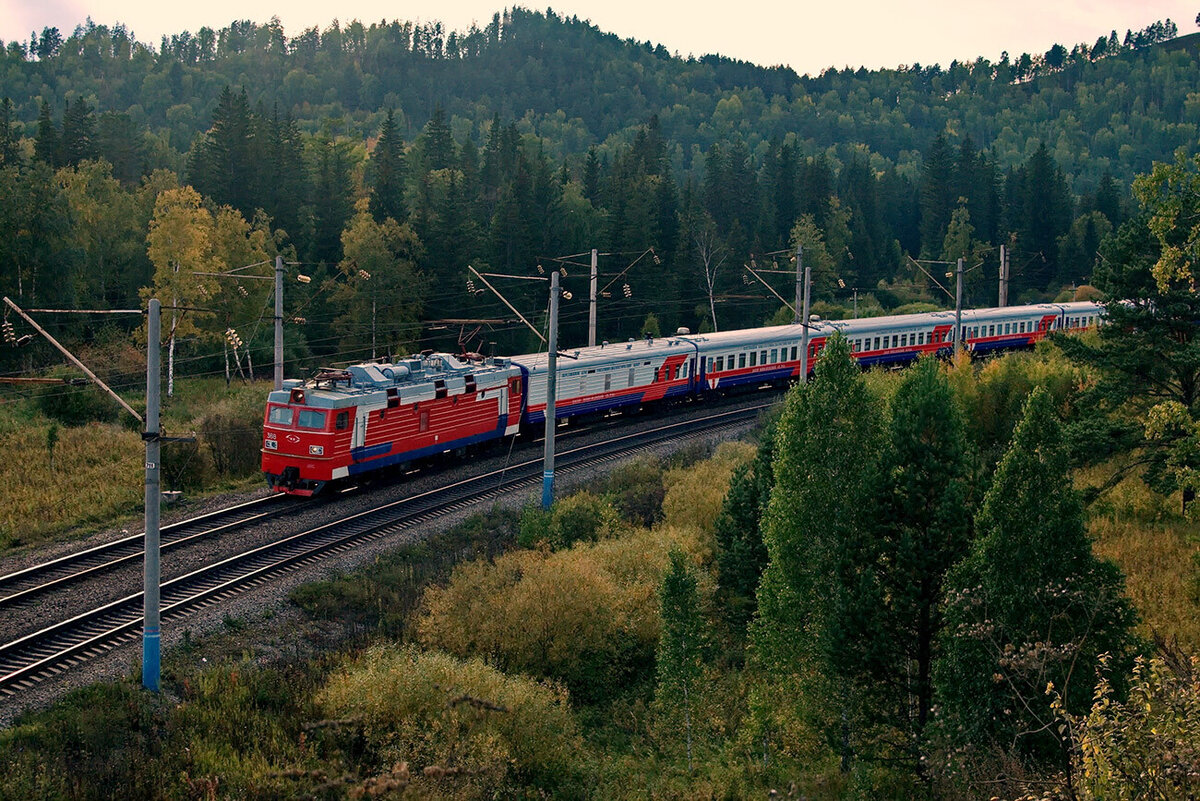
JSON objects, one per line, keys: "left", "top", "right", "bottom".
{"left": 654, "top": 550, "right": 703, "bottom": 772}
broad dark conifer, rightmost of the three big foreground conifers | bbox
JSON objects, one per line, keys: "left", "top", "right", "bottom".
{"left": 935, "top": 389, "right": 1135, "bottom": 761}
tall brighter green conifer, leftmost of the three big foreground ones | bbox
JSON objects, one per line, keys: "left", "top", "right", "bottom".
{"left": 751, "top": 336, "right": 881, "bottom": 769}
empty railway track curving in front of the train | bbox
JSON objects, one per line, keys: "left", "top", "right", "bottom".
{"left": 0, "top": 403, "right": 769, "bottom": 697}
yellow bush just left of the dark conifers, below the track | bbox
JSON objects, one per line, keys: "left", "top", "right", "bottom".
{"left": 662, "top": 442, "right": 756, "bottom": 556}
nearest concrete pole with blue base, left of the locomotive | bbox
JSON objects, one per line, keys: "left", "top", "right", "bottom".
{"left": 142, "top": 297, "right": 162, "bottom": 692}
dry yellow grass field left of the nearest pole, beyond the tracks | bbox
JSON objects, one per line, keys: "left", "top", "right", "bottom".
{"left": 0, "top": 423, "right": 145, "bottom": 549}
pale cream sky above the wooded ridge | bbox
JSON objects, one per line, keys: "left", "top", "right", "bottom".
{"left": 0, "top": 0, "right": 1200, "bottom": 74}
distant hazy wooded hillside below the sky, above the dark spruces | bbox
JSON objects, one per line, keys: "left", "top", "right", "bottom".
{"left": 0, "top": 8, "right": 1200, "bottom": 188}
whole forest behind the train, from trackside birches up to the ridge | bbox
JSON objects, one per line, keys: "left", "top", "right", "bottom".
{"left": 0, "top": 8, "right": 1200, "bottom": 381}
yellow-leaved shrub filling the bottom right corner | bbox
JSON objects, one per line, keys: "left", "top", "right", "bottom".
{"left": 1074, "top": 657, "right": 1200, "bottom": 801}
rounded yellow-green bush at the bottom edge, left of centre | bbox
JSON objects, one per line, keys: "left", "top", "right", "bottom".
{"left": 317, "top": 646, "right": 583, "bottom": 799}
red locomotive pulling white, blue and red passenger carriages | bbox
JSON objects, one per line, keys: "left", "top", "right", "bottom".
{"left": 262, "top": 302, "right": 1103, "bottom": 495}
